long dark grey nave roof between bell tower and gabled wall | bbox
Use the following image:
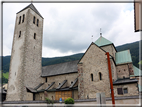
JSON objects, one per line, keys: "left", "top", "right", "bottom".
{"left": 41, "top": 60, "right": 78, "bottom": 77}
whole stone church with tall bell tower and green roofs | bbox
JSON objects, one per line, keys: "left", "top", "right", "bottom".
{"left": 6, "top": 3, "right": 141, "bottom": 101}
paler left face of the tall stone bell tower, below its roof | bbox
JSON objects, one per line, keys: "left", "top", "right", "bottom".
{"left": 6, "top": 10, "right": 28, "bottom": 101}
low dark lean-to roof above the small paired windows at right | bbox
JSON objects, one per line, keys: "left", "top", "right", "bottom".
{"left": 113, "top": 78, "right": 138, "bottom": 85}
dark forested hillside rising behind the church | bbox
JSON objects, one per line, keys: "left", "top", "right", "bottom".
{"left": 0, "top": 42, "right": 139, "bottom": 83}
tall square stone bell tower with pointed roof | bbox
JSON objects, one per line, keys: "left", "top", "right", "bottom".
{"left": 6, "top": 3, "right": 43, "bottom": 101}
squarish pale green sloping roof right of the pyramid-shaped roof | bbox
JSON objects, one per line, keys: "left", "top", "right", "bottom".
{"left": 115, "top": 50, "right": 132, "bottom": 65}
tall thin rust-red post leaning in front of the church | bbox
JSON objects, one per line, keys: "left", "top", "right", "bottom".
{"left": 105, "top": 52, "right": 115, "bottom": 107}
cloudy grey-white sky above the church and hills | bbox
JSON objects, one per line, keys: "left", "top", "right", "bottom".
{"left": 3, "top": 3, "right": 140, "bottom": 57}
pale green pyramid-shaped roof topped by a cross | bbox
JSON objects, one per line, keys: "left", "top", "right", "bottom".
{"left": 94, "top": 36, "right": 113, "bottom": 46}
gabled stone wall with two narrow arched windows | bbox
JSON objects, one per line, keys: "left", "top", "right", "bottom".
{"left": 78, "top": 44, "right": 110, "bottom": 99}
